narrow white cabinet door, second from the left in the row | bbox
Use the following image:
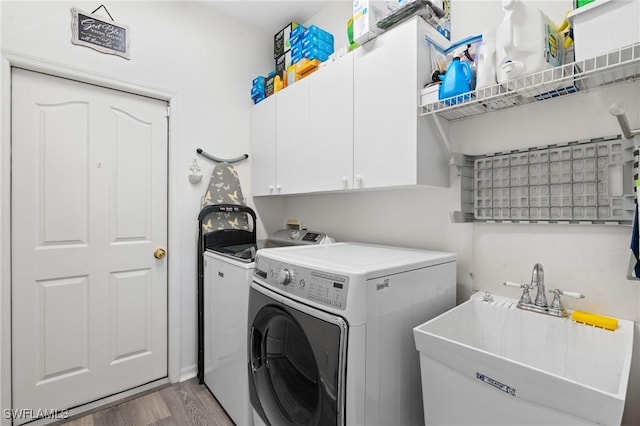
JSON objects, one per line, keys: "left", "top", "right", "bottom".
{"left": 276, "top": 79, "right": 311, "bottom": 194}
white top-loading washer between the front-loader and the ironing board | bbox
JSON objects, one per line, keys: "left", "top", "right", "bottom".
{"left": 201, "top": 229, "right": 333, "bottom": 426}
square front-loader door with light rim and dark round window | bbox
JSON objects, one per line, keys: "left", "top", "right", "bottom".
{"left": 248, "top": 288, "right": 347, "bottom": 426}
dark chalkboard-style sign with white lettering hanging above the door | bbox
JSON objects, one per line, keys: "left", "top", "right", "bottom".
{"left": 71, "top": 8, "right": 130, "bottom": 59}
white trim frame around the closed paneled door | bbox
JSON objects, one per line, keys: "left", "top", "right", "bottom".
{"left": 0, "top": 50, "right": 181, "bottom": 425}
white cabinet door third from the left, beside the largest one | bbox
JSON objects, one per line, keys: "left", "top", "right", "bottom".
{"left": 304, "top": 53, "right": 353, "bottom": 191}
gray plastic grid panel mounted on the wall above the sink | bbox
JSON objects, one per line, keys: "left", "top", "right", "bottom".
{"left": 473, "top": 138, "right": 634, "bottom": 223}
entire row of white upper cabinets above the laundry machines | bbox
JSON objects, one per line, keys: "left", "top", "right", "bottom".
{"left": 252, "top": 17, "right": 449, "bottom": 195}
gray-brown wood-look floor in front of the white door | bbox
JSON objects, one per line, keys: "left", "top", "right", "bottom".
{"left": 62, "top": 379, "right": 234, "bottom": 426}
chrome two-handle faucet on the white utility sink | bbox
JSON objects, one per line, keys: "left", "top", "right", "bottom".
{"left": 504, "top": 263, "right": 584, "bottom": 317}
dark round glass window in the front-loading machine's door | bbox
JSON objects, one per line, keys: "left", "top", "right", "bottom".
{"left": 251, "top": 307, "right": 321, "bottom": 425}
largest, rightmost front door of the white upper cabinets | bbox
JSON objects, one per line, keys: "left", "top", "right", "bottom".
{"left": 353, "top": 18, "right": 424, "bottom": 188}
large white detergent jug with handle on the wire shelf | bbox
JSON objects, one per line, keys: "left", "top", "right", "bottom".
{"left": 496, "top": 0, "right": 562, "bottom": 83}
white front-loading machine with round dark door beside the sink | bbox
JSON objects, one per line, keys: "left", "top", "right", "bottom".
{"left": 247, "top": 243, "right": 456, "bottom": 426}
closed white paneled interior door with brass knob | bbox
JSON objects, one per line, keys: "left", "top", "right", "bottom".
{"left": 11, "top": 69, "right": 167, "bottom": 418}
